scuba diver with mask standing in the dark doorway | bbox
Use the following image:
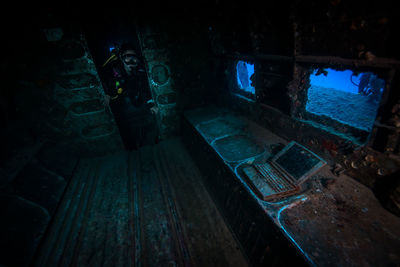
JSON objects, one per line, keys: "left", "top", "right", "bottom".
{"left": 102, "top": 43, "right": 159, "bottom": 150}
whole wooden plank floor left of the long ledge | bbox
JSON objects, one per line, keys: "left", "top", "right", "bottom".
{"left": 34, "top": 139, "right": 247, "bottom": 266}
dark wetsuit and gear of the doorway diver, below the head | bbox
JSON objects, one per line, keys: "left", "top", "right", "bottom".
{"left": 103, "top": 56, "right": 158, "bottom": 150}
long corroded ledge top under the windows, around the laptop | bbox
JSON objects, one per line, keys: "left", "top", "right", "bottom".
{"left": 185, "top": 106, "right": 400, "bottom": 266}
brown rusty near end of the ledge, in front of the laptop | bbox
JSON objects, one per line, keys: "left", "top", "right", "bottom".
{"left": 279, "top": 171, "right": 400, "bottom": 266}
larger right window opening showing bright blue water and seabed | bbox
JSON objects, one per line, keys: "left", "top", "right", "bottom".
{"left": 306, "top": 68, "right": 385, "bottom": 131}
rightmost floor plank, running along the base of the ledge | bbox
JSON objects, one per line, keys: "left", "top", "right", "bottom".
{"left": 161, "top": 139, "right": 246, "bottom": 266}
